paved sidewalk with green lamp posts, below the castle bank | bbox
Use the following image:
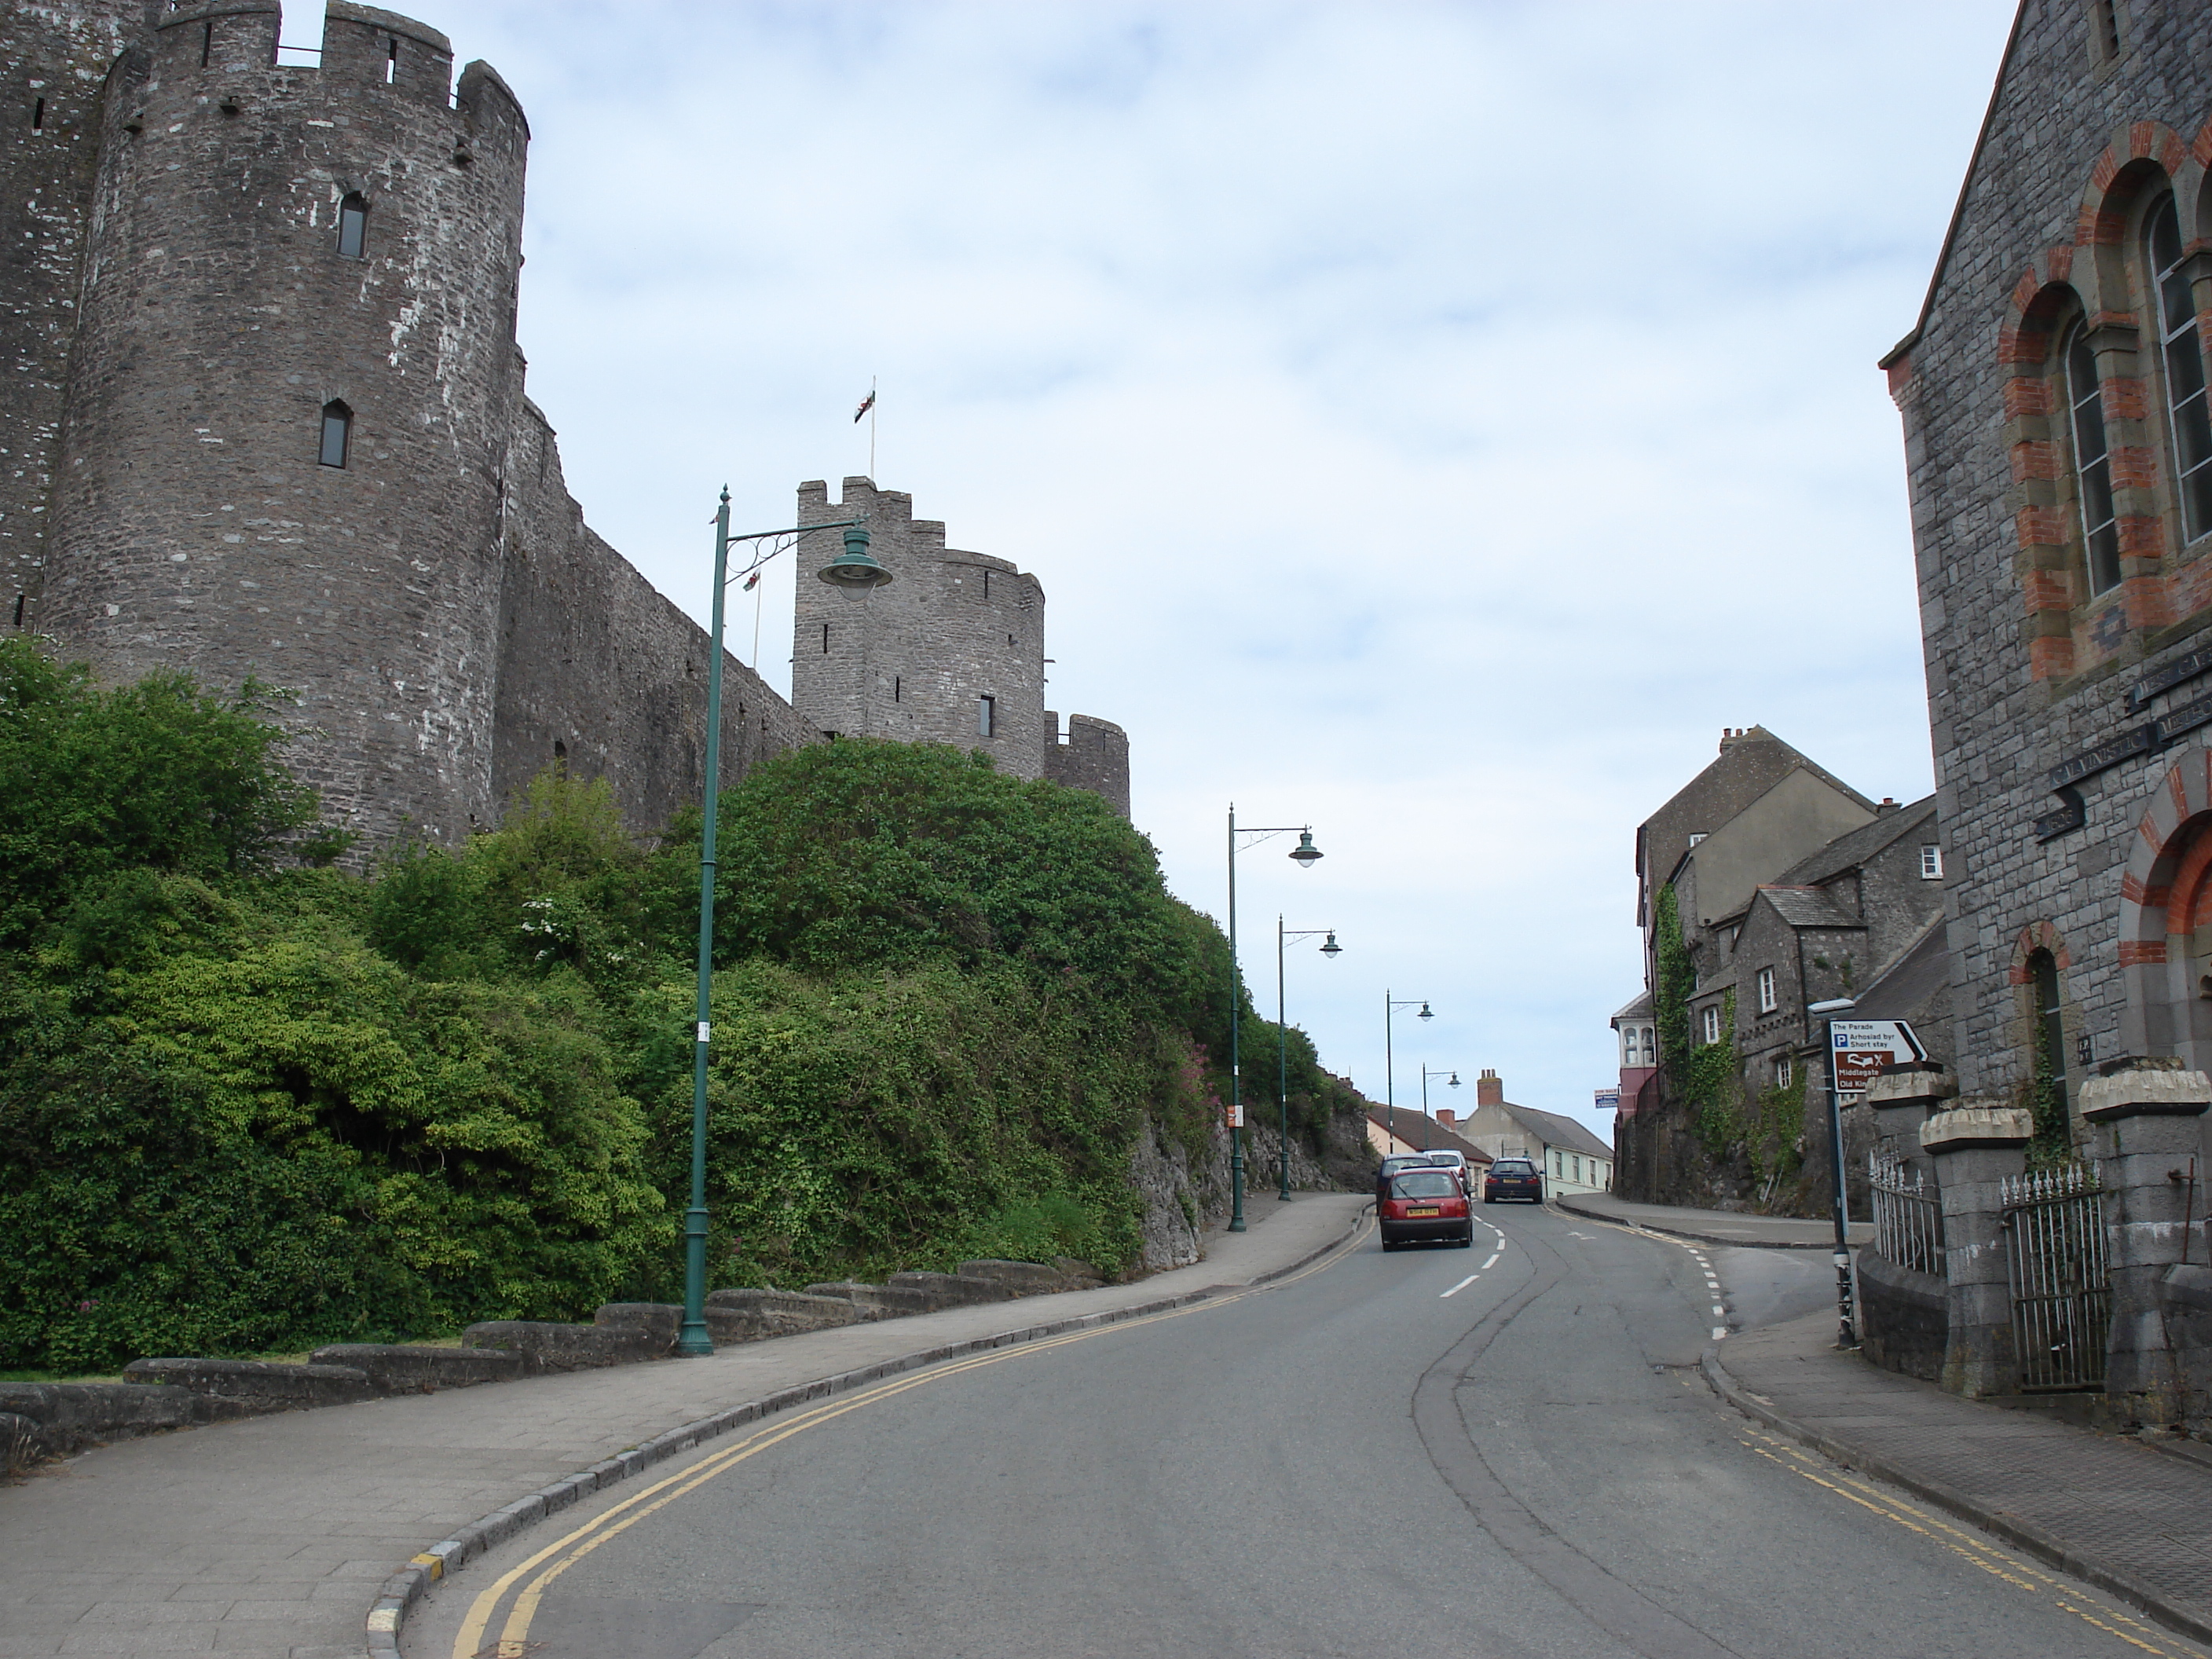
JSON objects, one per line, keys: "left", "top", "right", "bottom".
{"left": 0, "top": 1192, "right": 1369, "bottom": 1659}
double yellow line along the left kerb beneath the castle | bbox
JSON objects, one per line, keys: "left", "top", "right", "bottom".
{"left": 453, "top": 1221, "right": 1374, "bottom": 1659}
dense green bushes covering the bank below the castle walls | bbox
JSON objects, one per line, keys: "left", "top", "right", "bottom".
{"left": 0, "top": 642, "right": 1358, "bottom": 1369}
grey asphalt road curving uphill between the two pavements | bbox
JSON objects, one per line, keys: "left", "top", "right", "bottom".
{"left": 407, "top": 1206, "right": 2199, "bottom": 1659}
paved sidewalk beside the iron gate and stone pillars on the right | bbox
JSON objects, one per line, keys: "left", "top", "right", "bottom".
{"left": 1705, "top": 1314, "right": 2212, "bottom": 1641}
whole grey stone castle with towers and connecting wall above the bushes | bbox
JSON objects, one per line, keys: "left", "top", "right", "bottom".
{"left": 0, "top": 0, "right": 1128, "bottom": 845}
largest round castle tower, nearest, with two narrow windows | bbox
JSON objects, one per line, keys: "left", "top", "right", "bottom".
{"left": 35, "top": 0, "right": 529, "bottom": 843}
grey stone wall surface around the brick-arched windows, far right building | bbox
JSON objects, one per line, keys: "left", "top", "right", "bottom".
{"left": 1887, "top": 0, "right": 2212, "bottom": 1095}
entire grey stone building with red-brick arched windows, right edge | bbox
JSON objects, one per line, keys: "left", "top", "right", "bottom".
{"left": 1882, "top": 0, "right": 2212, "bottom": 1132}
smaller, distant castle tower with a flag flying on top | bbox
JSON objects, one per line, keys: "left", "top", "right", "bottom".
{"left": 792, "top": 478, "right": 1053, "bottom": 782}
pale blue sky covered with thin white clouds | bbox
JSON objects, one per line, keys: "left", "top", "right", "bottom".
{"left": 397, "top": 0, "right": 2011, "bottom": 1133}
